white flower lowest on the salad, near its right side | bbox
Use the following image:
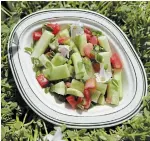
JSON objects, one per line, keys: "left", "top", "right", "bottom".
{"left": 95, "top": 65, "right": 112, "bottom": 83}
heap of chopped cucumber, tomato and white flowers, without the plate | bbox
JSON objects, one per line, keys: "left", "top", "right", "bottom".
{"left": 25, "top": 21, "right": 123, "bottom": 110}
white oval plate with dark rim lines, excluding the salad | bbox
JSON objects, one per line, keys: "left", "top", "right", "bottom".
{"left": 8, "top": 9, "right": 147, "bottom": 128}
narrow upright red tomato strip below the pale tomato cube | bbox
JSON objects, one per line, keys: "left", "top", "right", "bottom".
{"left": 84, "top": 89, "right": 91, "bottom": 109}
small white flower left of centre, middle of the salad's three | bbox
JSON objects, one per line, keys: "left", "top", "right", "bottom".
{"left": 58, "top": 45, "right": 70, "bottom": 58}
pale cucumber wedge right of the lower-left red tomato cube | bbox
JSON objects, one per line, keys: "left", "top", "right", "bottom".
{"left": 50, "top": 81, "right": 66, "bottom": 95}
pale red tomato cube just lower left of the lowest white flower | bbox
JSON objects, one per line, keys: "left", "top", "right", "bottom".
{"left": 84, "top": 78, "right": 96, "bottom": 89}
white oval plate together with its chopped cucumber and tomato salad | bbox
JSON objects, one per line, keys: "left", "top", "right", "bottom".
{"left": 8, "top": 9, "right": 147, "bottom": 128}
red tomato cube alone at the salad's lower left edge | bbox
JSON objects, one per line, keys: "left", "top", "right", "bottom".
{"left": 36, "top": 74, "right": 49, "bottom": 88}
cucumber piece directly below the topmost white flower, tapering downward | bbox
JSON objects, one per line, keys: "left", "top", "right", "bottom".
{"left": 75, "top": 34, "right": 87, "bottom": 56}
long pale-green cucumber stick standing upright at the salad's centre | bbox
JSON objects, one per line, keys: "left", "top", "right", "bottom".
{"left": 71, "top": 52, "right": 88, "bottom": 80}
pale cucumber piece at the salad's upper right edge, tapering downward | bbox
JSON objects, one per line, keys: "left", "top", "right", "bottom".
{"left": 98, "top": 36, "right": 112, "bottom": 55}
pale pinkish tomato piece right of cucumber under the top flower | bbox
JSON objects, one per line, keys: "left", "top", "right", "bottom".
{"left": 84, "top": 43, "right": 95, "bottom": 59}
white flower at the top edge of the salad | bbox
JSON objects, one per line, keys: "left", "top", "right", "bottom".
{"left": 71, "top": 21, "right": 84, "bottom": 38}
